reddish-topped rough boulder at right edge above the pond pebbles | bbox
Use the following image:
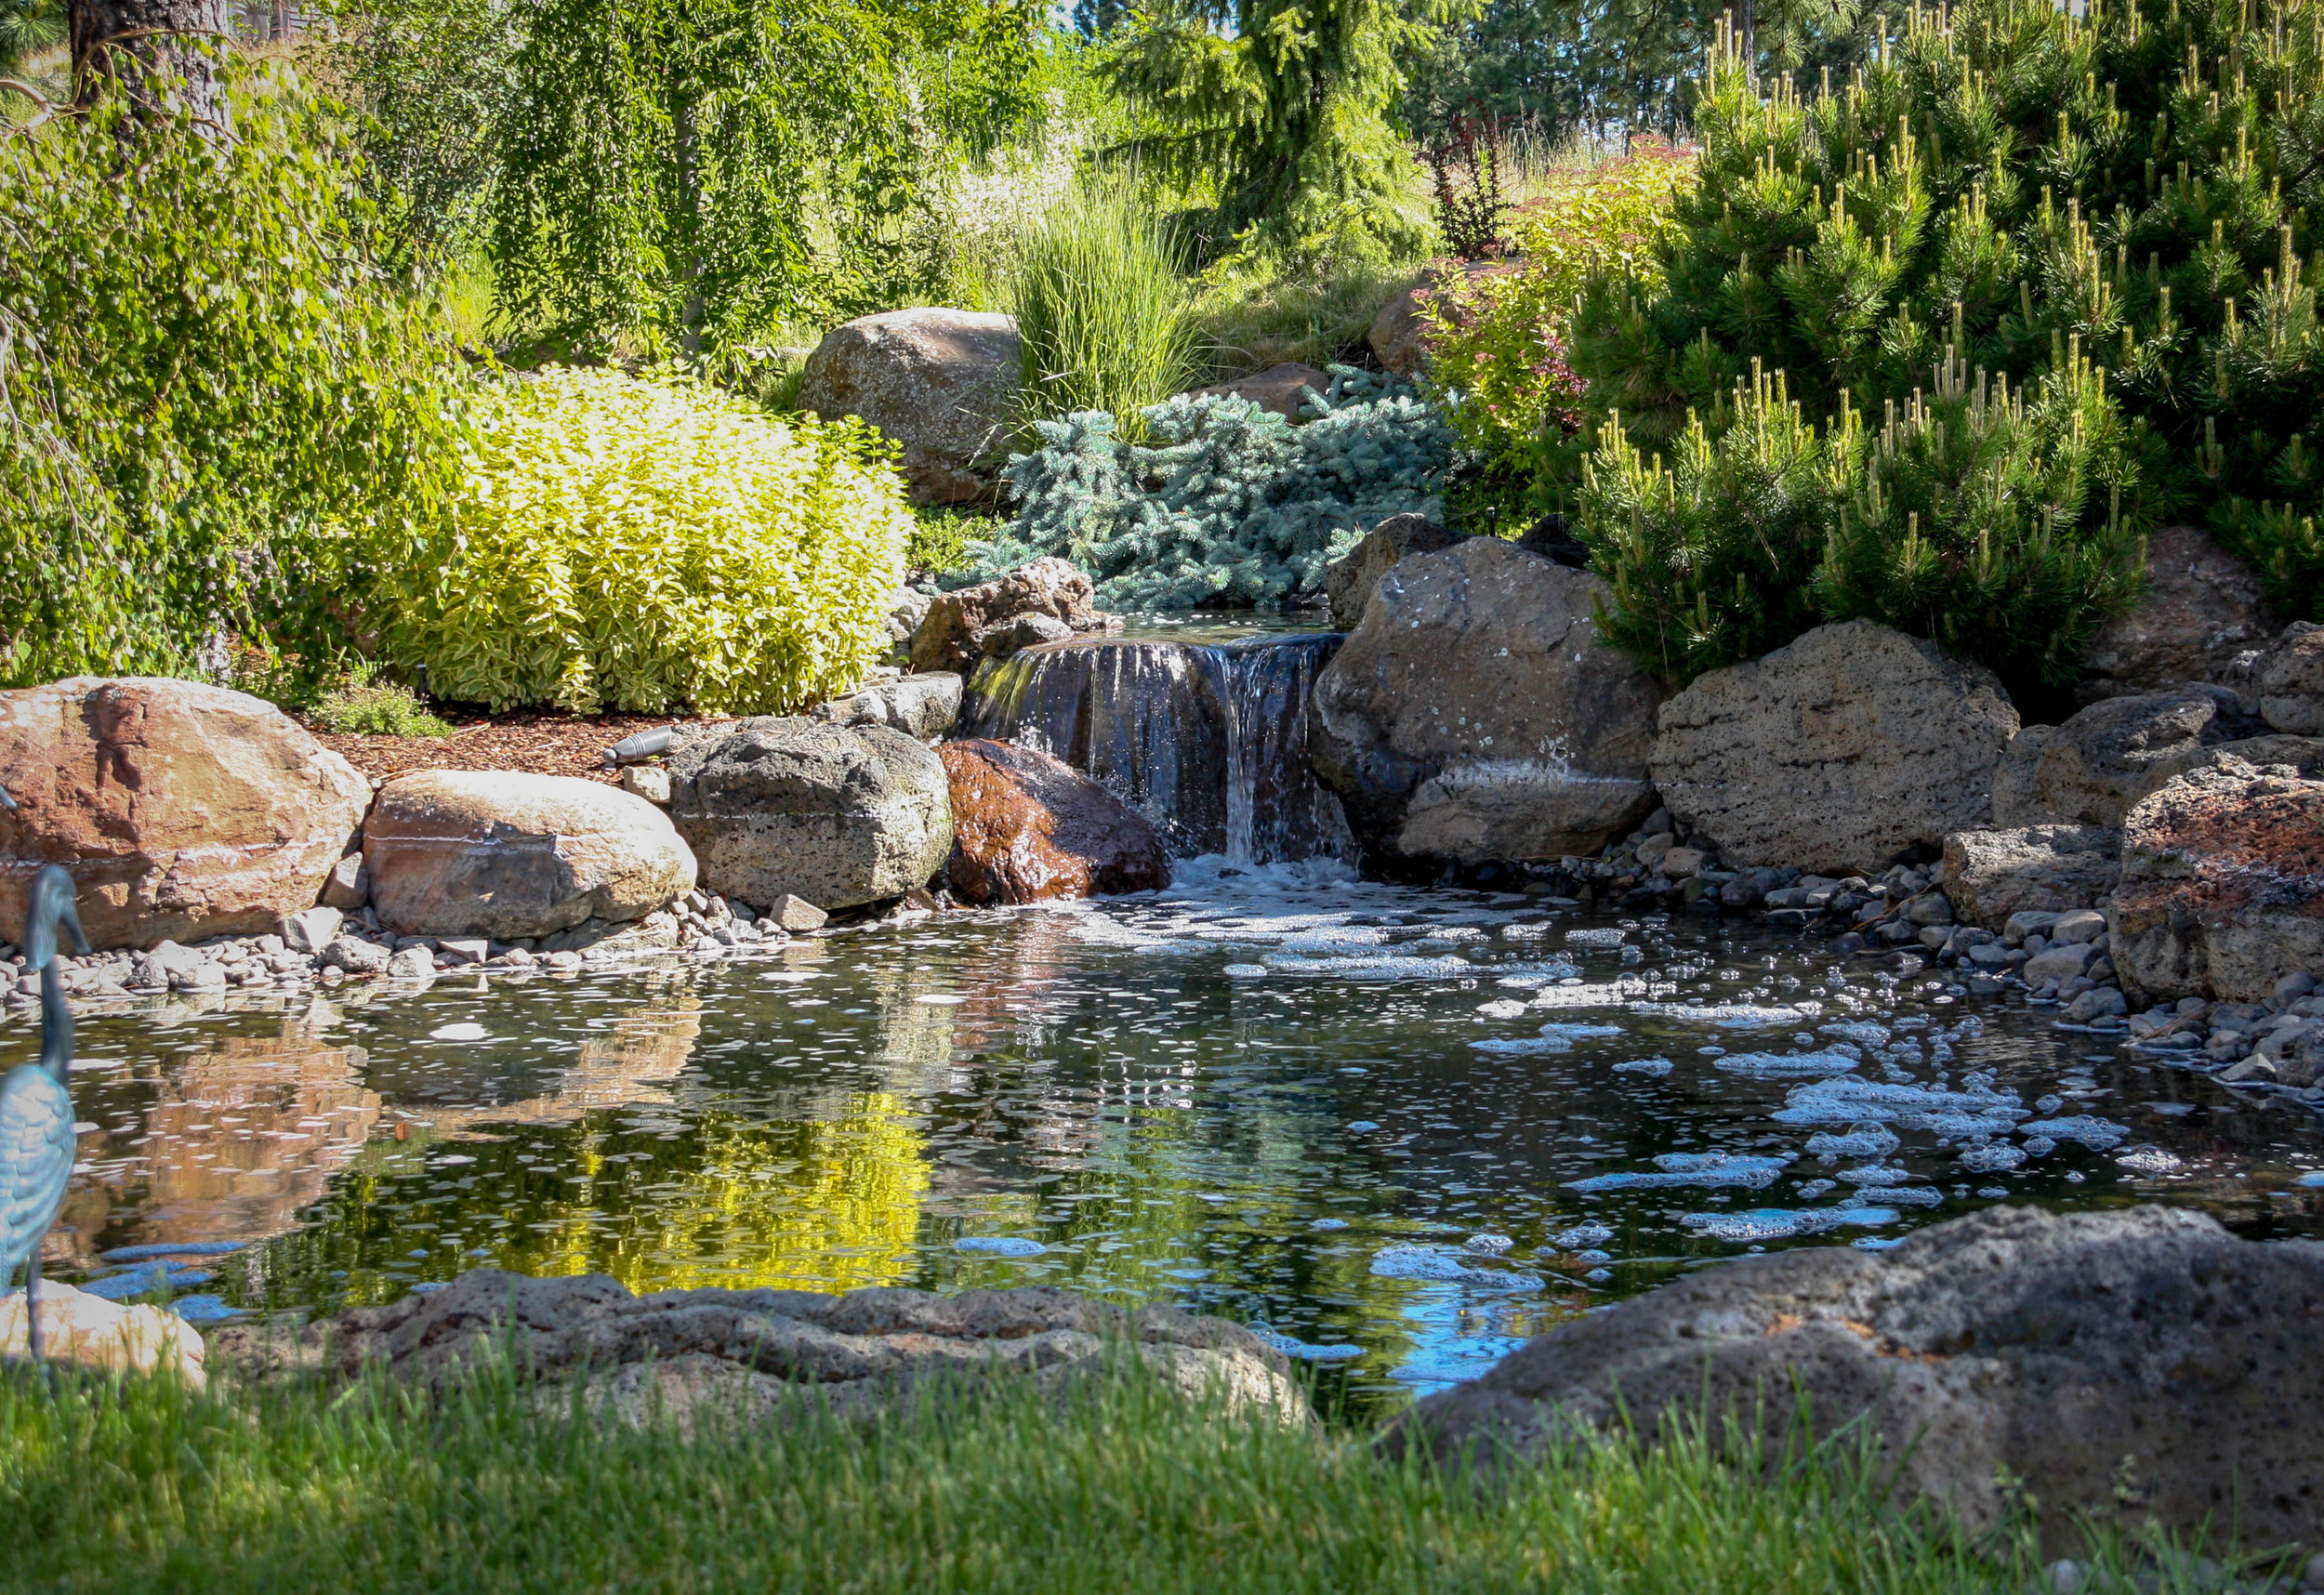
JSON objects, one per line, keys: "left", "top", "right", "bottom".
{"left": 2106, "top": 762, "right": 2324, "bottom": 1002}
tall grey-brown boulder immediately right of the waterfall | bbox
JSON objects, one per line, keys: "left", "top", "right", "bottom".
{"left": 1309, "top": 537, "right": 1662, "bottom": 863}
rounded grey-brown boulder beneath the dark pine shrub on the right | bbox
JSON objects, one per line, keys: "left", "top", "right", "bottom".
{"left": 1655, "top": 621, "right": 2017, "bottom": 877}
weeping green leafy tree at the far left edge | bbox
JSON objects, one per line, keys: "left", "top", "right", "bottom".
{"left": 0, "top": 56, "right": 463, "bottom": 686}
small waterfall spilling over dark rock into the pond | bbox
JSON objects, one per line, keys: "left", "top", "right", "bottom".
{"left": 960, "top": 632, "right": 1355, "bottom": 865}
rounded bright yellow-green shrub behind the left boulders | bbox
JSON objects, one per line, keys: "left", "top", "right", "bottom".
{"left": 364, "top": 367, "right": 911, "bottom": 714}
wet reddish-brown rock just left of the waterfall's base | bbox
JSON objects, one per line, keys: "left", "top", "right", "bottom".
{"left": 937, "top": 739, "right": 1169, "bottom": 903}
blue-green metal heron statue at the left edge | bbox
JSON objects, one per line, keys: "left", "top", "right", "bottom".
{"left": 0, "top": 785, "right": 88, "bottom": 1363}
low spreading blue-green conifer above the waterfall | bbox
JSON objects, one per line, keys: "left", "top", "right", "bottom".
{"left": 971, "top": 367, "right": 1458, "bottom": 609}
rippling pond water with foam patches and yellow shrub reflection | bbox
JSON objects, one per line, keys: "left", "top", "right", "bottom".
{"left": 18, "top": 861, "right": 2324, "bottom": 1409}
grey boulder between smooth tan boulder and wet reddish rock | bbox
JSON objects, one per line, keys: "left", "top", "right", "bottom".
{"left": 669, "top": 716, "right": 953, "bottom": 909}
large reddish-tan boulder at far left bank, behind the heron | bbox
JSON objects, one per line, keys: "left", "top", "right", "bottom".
{"left": 0, "top": 677, "right": 372, "bottom": 946}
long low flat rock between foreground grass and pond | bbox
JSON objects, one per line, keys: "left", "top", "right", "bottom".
{"left": 217, "top": 1267, "right": 1311, "bottom": 1425}
